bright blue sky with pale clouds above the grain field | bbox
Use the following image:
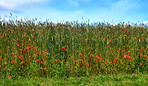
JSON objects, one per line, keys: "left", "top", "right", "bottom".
{"left": 0, "top": 0, "right": 148, "bottom": 23}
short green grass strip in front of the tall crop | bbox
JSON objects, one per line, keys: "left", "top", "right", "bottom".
{"left": 0, "top": 74, "right": 148, "bottom": 86}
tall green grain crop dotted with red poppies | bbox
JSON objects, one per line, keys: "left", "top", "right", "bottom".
{"left": 0, "top": 18, "right": 148, "bottom": 78}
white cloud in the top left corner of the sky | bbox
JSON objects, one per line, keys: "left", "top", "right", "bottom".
{"left": 0, "top": 0, "right": 43, "bottom": 9}
